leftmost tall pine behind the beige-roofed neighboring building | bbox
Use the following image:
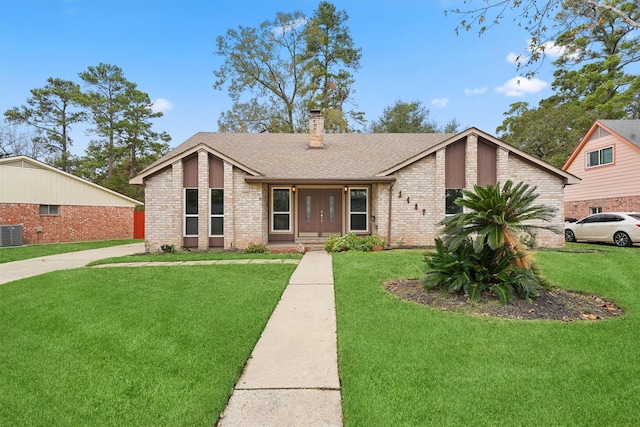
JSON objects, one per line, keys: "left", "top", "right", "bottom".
{"left": 4, "top": 77, "right": 86, "bottom": 172}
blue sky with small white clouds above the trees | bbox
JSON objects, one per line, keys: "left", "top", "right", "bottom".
{"left": 0, "top": 0, "right": 552, "bottom": 155}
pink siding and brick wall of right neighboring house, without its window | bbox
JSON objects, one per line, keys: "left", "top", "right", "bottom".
{"left": 564, "top": 131, "right": 640, "bottom": 218}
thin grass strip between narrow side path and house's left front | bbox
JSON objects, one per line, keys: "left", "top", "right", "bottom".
{"left": 89, "top": 251, "right": 302, "bottom": 265}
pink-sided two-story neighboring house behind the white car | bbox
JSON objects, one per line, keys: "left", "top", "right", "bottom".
{"left": 562, "top": 120, "right": 640, "bottom": 219}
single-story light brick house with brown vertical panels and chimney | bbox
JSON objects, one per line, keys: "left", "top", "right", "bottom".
{"left": 130, "top": 113, "right": 579, "bottom": 251}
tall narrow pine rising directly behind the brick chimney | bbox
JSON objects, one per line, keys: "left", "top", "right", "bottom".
{"left": 305, "top": 1, "right": 364, "bottom": 132}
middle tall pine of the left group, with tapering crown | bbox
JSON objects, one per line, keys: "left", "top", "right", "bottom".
{"left": 79, "top": 63, "right": 136, "bottom": 179}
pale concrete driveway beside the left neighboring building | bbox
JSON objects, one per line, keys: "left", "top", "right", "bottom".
{"left": 0, "top": 243, "right": 144, "bottom": 285}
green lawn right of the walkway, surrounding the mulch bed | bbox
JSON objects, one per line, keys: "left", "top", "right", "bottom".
{"left": 333, "top": 245, "right": 640, "bottom": 426}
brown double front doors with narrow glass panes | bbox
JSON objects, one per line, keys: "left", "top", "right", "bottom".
{"left": 298, "top": 188, "right": 342, "bottom": 237}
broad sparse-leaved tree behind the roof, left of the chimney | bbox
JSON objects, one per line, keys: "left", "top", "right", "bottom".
{"left": 213, "top": 11, "right": 309, "bottom": 133}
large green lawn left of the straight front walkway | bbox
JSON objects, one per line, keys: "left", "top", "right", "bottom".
{"left": 0, "top": 265, "right": 295, "bottom": 426}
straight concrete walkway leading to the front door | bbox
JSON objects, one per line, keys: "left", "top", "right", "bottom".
{"left": 218, "top": 252, "right": 342, "bottom": 427}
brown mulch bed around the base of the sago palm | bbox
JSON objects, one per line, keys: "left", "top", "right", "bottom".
{"left": 384, "top": 279, "right": 624, "bottom": 322}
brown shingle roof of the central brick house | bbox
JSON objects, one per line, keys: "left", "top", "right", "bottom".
{"left": 142, "top": 132, "right": 455, "bottom": 179}
